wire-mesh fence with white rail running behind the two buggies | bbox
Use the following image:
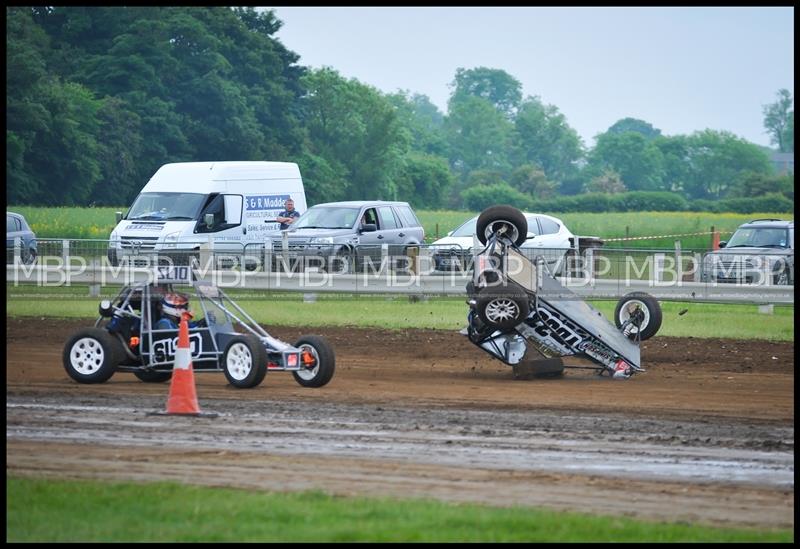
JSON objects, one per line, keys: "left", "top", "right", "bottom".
{"left": 6, "top": 239, "right": 794, "bottom": 304}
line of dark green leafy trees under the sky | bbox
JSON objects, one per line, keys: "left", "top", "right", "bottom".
{"left": 6, "top": 6, "right": 794, "bottom": 209}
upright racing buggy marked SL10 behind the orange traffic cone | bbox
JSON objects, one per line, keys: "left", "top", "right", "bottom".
{"left": 63, "top": 266, "right": 336, "bottom": 388}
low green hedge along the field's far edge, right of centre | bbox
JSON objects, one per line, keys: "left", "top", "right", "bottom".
{"left": 463, "top": 184, "right": 794, "bottom": 214}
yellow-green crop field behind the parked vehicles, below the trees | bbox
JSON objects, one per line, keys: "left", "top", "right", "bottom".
{"left": 7, "top": 206, "right": 791, "bottom": 250}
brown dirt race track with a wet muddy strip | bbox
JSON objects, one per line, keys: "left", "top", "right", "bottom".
{"left": 6, "top": 319, "right": 794, "bottom": 527}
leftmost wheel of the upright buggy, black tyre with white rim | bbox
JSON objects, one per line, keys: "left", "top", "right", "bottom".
{"left": 63, "top": 328, "right": 120, "bottom": 383}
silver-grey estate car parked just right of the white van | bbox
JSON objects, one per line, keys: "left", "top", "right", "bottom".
{"left": 269, "top": 201, "right": 425, "bottom": 271}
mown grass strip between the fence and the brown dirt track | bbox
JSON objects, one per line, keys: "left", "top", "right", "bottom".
{"left": 6, "top": 284, "right": 794, "bottom": 341}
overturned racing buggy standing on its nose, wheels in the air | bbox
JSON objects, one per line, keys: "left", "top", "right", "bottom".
{"left": 462, "top": 206, "right": 662, "bottom": 379}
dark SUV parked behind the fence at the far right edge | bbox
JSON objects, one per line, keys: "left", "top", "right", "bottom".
{"left": 701, "top": 219, "right": 794, "bottom": 285}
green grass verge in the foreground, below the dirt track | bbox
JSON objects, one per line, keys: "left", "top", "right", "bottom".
{"left": 6, "top": 476, "right": 794, "bottom": 542}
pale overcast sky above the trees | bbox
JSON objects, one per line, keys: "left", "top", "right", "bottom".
{"left": 268, "top": 7, "right": 794, "bottom": 150}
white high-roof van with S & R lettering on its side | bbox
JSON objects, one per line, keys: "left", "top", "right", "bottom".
{"left": 108, "top": 162, "right": 306, "bottom": 265}
